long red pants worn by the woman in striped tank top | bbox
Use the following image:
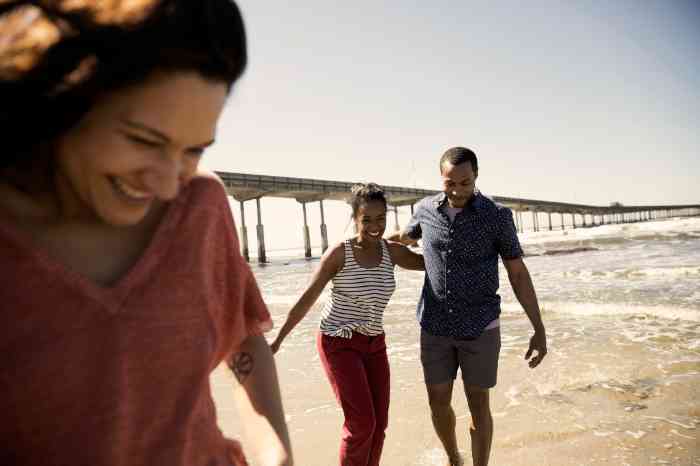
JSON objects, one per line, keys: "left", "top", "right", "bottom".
{"left": 316, "top": 332, "right": 389, "bottom": 466}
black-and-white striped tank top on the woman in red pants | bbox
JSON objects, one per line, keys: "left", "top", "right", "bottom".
{"left": 321, "top": 239, "right": 396, "bottom": 338}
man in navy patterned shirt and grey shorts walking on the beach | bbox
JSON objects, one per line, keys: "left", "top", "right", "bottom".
{"left": 390, "top": 147, "right": 547, "bottom": 466}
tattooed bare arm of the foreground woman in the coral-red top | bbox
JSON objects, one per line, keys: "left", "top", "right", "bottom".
{"left": 228, "top": 335, "right": 294, "bottom": 466}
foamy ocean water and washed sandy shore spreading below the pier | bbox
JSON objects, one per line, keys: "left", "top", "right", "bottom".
{"left": 213, "top": 218, "right": 700, "bottom": 466}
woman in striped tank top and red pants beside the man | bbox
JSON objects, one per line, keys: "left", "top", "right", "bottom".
{"left": 271, "top": 183, "right": 424, "bottom": 466}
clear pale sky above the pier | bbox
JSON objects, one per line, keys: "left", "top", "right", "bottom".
{"left": 205, "top": 0, "right": 700, "bottom": 253}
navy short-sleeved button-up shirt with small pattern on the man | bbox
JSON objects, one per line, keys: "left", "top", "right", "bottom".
{"left": 406, "top": 192, "right": 523, "bottom": 339}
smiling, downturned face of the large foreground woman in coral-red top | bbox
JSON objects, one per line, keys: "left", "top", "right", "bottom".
{"left": 55, "top": 72, "right": 227, "bottom": 226}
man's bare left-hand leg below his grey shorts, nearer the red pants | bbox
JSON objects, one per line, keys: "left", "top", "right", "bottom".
{"left": 426, "top": 381, "right": 462, "bottom": 466}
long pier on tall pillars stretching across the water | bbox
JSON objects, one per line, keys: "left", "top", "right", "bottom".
{"left": 216, "top": 171, "right": 700, "bottom": 263}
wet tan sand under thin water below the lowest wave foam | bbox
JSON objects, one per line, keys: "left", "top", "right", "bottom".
{"left": 213, "top": 316, "right": 700, "bottom": 466}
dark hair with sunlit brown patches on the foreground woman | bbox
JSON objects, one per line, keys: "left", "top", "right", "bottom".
{"left": 0, "top": 0, "right": 247, "bottom": 169}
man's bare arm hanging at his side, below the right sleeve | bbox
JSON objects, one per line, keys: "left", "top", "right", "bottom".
{"left": 503, "top": 257, "right": 547, "bottom": 367}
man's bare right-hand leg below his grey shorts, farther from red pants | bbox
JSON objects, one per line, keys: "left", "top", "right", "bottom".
{"left": 464, "top": 385, "right": 493, "bottom": 466}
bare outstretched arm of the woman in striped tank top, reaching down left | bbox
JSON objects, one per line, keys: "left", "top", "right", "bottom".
{"left": 270, "top": 243, "right": 345, "bottom": 354}
